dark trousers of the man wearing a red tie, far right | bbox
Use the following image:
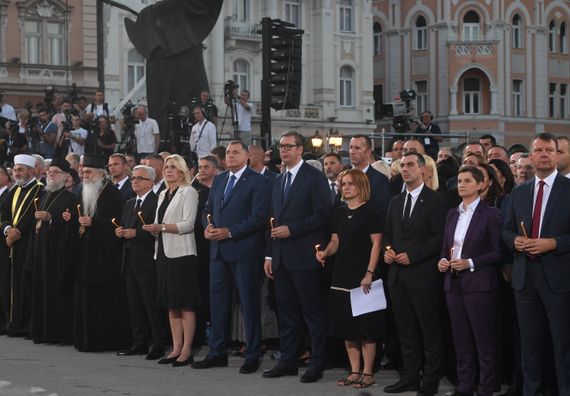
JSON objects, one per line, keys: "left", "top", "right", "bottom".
{"left": 515, "top": 261, "right": 570, "bottom": 396}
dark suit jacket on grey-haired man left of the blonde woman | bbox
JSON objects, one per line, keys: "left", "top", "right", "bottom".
{"left": 121, "top": 190, "right": 158, "bottom": 273}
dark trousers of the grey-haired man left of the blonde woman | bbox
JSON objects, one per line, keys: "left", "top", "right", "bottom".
{"left": 125, "top": 253, "right": 169, "bottom": 345}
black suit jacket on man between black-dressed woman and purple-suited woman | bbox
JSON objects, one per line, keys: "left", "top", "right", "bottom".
{"left": 382, "top": 186, "right": 445, "bottom": 290}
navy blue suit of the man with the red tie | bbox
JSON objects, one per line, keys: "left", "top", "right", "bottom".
{"left": 503, "top": 174, "right": 570, "bottom": 395}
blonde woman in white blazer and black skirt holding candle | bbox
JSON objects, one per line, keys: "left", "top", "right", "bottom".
{"left": 143, "top": 154, "right": 202, "bottom": 367}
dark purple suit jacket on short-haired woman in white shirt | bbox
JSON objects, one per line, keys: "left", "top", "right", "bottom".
{"left": 440, "top": 201, "right": 502, "bottom": 293}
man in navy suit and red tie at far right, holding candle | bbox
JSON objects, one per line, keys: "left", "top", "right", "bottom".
{"left": 503, "top": 133, "right": 570, "bottom": 395}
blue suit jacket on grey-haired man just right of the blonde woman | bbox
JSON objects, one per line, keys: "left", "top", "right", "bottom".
{"left": 203, "top": 167, "right": 269, "bottom": 262}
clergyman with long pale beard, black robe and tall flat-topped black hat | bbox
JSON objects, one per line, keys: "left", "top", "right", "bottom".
{"left": 64, "top": 154, "right": 130, "bottom": 351}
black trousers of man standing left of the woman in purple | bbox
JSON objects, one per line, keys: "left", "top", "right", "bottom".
{"left": 390, "top": 282, "right": 443, "bottom": 386}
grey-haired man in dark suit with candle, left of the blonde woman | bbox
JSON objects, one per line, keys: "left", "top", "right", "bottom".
{"left": 115, "top": 165, "right": 169, "bottom": 360}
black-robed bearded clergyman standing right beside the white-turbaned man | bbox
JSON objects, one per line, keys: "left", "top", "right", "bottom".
{"left": 28, "top": 158, "right": 78, "bottom": 344}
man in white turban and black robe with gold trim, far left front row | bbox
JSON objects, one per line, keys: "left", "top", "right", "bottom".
{"left": 0, "top": 154, "right": 43, "bottom": 336}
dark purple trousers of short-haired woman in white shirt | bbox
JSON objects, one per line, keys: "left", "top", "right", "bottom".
{"left": 446, "top": 278, "right": 497, "bottom": 396}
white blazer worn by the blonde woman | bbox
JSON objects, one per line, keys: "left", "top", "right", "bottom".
{"left": 154, "top": 186, "right": 198, "bottom": 259}
